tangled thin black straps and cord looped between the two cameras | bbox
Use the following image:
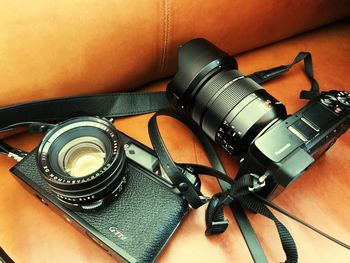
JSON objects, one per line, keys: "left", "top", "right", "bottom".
{"left": 148, "top": 109, "right": 350, "bottom": 263}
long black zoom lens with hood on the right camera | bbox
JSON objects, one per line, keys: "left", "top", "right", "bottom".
{"left": 167, "top": 39, "right": 286, "bottom": 154}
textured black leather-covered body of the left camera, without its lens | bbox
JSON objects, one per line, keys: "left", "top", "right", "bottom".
{"left": 11, "top": 134, "right": 188, "bottom": 262}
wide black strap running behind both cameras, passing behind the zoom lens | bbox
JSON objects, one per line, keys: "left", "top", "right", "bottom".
{"left": 0, "top": 52, "right": 320, "bottom": 131}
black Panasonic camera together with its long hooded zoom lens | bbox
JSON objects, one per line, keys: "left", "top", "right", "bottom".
{"left": 167, "top": 39, "right": 350, "bottom": 199}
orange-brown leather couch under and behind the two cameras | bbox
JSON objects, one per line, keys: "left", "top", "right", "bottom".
{"left": 0, "top": 0, "right": 350, "bottom": 263}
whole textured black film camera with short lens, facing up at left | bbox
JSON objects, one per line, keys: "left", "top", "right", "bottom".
{"left": 11, "top": 117, "right": 189, "bottom": 262}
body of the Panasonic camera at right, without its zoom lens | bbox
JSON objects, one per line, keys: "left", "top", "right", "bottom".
{"left": 235, "top": 90, "right": 350, "bottom": 199}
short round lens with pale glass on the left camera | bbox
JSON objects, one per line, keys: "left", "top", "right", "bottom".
{"left": 37, "top": 117, "right": 127, "bottom": 211}
